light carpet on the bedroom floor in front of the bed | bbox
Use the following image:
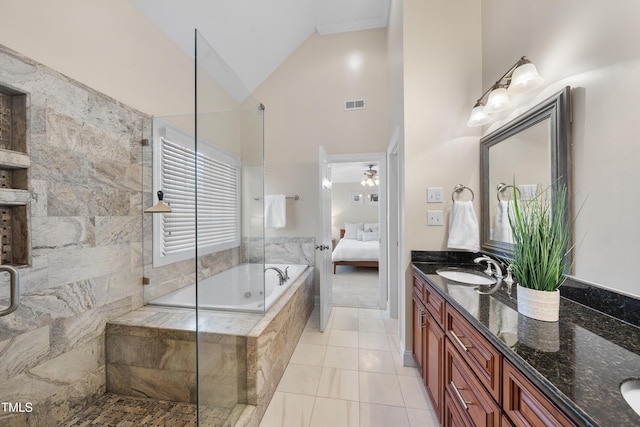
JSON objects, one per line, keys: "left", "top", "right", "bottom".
{"left": 332, "top": 265, "right": 380, "bottom": 308}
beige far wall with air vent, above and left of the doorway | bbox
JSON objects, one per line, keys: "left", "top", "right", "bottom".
{"left": 255, "top": 29, "right": 389, "bottom": 241}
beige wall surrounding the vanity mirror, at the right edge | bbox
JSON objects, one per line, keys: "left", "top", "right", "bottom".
{"left": 482, "top": 0, "right": 640, "bottom": 295}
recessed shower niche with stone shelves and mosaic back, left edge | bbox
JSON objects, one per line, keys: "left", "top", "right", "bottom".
{"left": 0, "top": 84, "right": 31, "bottom": 266}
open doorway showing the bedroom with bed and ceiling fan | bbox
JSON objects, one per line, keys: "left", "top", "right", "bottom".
{"left": 331, "top": 154, "right": 387, "bottom": 309}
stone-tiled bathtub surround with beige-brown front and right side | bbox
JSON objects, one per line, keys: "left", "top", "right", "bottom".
{"left": 106, "top": 268, "right": 314, "bottom": 425}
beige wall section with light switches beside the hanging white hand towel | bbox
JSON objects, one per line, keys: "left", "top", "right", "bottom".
{"left": 401, "top": 0, "right": 482, "bottom": 347}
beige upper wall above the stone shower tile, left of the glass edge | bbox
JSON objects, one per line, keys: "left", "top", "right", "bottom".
{"left": 0, "top": 0, "right": 194, "bottom": 116}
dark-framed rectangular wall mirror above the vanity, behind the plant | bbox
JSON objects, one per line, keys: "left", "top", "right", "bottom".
{"left": 480, "top": 87, "right": 571, "bottom": 258}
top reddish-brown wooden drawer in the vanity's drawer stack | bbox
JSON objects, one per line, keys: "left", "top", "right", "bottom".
{"left": 445, "top": 304, "right": 502, "bottom": 403}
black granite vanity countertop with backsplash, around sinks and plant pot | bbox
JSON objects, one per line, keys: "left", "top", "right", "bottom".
{"left": 412, "top": 252, "right": 640, "bottom": 427}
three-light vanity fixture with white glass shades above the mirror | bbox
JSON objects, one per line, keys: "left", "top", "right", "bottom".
{"left": 467, "top": 56, "right": 544, "bottom": 127}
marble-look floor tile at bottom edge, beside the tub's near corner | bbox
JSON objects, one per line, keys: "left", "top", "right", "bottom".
{"left": 260, "top": 391, "right": 316, "bottom": 427}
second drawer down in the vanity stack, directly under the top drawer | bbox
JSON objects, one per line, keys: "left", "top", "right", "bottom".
{"left": 445, "top": 342, "right": 502, "bottom": 427}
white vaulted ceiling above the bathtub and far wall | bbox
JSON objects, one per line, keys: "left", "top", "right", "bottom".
{"left": 132, "top": 0, "right": 389, "bottom": 92}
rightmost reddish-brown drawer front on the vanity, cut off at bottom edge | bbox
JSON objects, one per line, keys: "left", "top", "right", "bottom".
{"left": 503, "top": 360, "right": 575, "bottom": 427}
